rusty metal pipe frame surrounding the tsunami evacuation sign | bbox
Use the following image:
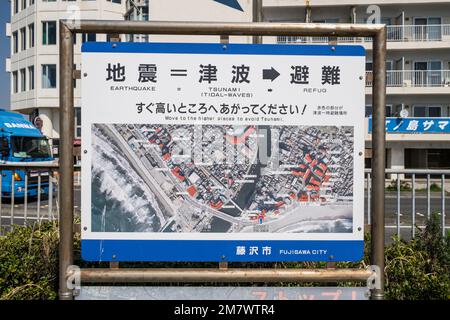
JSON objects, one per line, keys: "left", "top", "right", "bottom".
{"left": 59, "top": 20, "right": 386, "bottom": 300}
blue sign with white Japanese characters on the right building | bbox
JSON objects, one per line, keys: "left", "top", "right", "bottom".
{"left": 369, "top": 117, "right": 450, "bottom": 133}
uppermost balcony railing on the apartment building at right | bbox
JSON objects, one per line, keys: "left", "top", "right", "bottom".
{"left": 277, "top": 24, "right": 450, "bottom": 44}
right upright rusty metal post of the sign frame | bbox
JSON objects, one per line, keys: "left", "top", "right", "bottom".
{"left": 371, "top": 26, "right": 386, "bottom": 300}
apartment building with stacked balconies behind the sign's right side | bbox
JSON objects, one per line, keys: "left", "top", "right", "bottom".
{"left": 263, "top": 0, "right": 450, "bottom": 169}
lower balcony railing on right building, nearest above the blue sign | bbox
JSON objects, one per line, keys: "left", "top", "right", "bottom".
{"left": 366, "top": 70, "right": 450, "bottom": 88}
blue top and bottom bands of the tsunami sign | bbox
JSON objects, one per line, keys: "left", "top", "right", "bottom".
{"left": 81, "top": 42, "right": 365, "bottom": 262}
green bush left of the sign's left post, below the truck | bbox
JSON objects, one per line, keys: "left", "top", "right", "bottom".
{"left": 0, "top": 222, "right": 58, "bottom": 300}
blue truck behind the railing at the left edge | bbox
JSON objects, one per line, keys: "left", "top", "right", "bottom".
{"left": 0, "top": 109, "right": 54, "bottom": 198}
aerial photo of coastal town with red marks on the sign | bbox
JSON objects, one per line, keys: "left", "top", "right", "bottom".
{"left": 91, "top": 124, "right": 354, "bottom": 233}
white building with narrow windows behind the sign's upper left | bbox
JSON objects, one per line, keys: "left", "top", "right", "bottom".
{"left": 6, "top": 0, "right": 125, "bottom": 153}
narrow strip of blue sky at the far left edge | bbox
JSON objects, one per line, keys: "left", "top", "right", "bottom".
{"left": 0, "top": 0, "right": 11, "bottom": 109}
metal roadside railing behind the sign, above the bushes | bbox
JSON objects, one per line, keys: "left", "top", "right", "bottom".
{"left": 0, "top": 163, "right": 450, "bottom": 238}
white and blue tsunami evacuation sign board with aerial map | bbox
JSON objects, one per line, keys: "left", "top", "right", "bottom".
{"left": 82, "top": 43, "right": 365, "bottom": 261}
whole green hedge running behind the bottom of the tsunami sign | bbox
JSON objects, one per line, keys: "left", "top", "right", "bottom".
{"left": 0, "top": 215, "right": 450, "bottom": 300}
